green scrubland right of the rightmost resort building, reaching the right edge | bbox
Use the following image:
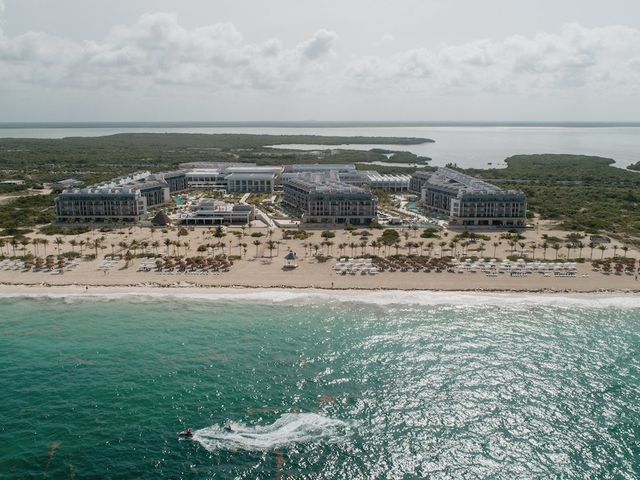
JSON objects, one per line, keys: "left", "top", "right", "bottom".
{"left": 465, "top": 155, "right": 640, "bottom": 237}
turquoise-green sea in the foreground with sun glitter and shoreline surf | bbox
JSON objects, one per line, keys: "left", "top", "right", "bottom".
{"left": 0, "top": 292, "right": 640, "bottom": 479}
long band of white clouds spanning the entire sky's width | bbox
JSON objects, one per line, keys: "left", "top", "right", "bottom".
{"left": 0, "top": 15, "right": 640, "bottom": 101}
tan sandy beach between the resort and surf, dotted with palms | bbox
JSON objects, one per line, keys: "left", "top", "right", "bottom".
{"left": 0, "top": 222, "right": 640, "bottom": 293}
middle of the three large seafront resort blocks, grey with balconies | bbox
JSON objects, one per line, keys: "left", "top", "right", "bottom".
{"left": 283, "top": 173, "right": 377, "bottom": 225}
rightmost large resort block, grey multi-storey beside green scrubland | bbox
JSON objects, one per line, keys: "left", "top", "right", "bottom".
{"left": 421, "top": 168, "right": 527, "bottom": 227}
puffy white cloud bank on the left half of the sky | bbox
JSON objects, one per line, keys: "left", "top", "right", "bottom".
{"left": 0, "top": 12, "right": 336, "bottom": 91}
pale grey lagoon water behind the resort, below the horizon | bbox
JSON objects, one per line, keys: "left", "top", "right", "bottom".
{"left": 0, "top": 122, "right": 640, "bottom": 168}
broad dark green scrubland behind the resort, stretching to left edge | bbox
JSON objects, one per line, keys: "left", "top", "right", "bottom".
{"left": 0, "top": 133, "right": 431, "bottom": 186}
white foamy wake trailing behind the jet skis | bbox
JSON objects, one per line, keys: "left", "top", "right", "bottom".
{"left": 193, "top": 413, "right": 348, "bottom": 452}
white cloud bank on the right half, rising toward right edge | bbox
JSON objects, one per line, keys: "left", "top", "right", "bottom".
{"left": 344, "top": 24, "right": 640, "bottom": 93}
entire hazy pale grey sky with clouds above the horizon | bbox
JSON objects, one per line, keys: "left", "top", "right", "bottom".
{"left": 0, "top": 0, "right": 640, "bottom": 122}
